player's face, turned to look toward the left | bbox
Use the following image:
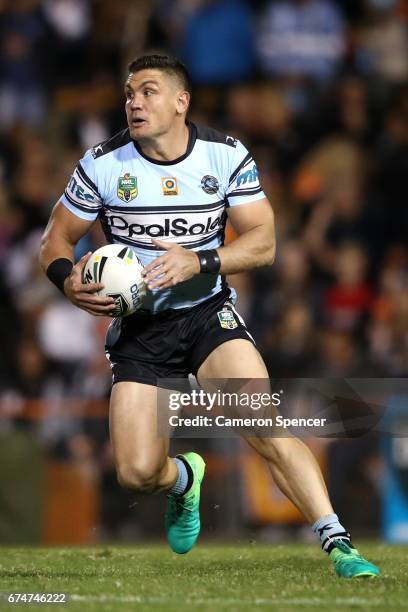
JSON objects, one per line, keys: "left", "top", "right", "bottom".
{"left": 125, "top": 69, "right": 188, "bottom": 140}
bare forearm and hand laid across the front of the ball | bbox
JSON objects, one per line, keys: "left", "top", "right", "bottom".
{"left": 145, "top": 198, "right": 276, "bottom": 289}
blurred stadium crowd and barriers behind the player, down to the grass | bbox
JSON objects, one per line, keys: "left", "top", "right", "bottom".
{"left": 0, "top": 0, "right": 408, "bottom": 543}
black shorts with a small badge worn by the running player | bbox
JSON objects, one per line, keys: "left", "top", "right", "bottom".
{"left": 105, "top": 289, "right": 255, "bottom": 386}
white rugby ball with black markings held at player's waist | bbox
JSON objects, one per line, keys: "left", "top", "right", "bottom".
{"left": 83, "top": 244, "right": 146, "bottom": 317}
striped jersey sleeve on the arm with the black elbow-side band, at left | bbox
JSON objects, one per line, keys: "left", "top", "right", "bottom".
{"left": 60, "top": 150, "right": 102, "bottom": 221}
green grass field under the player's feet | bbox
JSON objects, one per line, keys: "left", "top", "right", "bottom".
{"left": 0, "top": 543, "right": 408, "bottom": 612}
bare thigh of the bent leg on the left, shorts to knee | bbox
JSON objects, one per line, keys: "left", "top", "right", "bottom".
{"left": 109, "top": 382, "right": 169, "bottom": 471}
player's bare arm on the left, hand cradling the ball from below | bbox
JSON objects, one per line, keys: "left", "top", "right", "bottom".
{"left": 40, "top": 202, "right": 114, "bottom": 316}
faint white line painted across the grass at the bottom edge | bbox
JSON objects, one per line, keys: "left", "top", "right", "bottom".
{"left": 68, "top": 594, "right": 398, "bottom": 607}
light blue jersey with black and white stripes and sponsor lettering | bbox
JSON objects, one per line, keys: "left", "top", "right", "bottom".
{"left": 61, "top": 123, "right": 265, "bottom": 312}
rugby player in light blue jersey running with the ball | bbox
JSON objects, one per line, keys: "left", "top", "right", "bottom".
{"left": 40, "top": 55, "right": 379, "bottom": 578}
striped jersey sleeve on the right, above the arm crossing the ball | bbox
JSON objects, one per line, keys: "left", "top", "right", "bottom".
{"left": 225, "top": 140, "right": 265, "bottom": 206}
